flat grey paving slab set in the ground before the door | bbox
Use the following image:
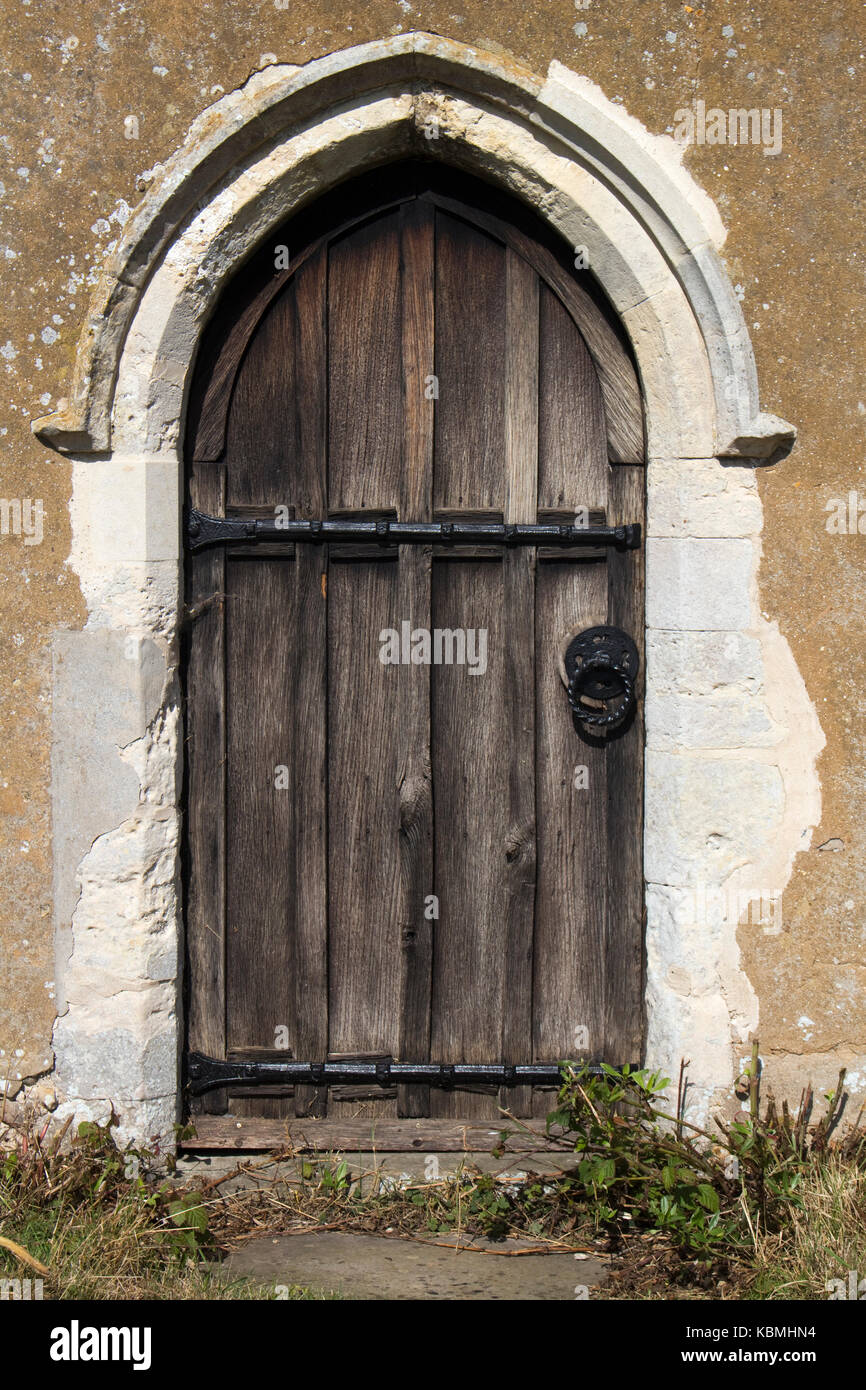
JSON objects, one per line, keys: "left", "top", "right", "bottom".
{"left": 221, "top": 1232, "right": 606, "bottom": 1301}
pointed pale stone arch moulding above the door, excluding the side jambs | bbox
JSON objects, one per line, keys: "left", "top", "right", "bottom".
{"left": 33, "top": 33, "right": 794, "bottom": 459}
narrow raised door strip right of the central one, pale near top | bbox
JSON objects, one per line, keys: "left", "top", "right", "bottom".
{"left": 500, "top": 249, "right": 538, "bottom": 1115}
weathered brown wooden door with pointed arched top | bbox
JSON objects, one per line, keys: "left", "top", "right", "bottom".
{"left": 186, "top": 164, "right": 644, "bottom": 1139}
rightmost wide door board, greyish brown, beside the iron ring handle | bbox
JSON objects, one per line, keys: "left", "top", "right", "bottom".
{"left": 532, "top": 288, "right": 608, "bottom": 1115}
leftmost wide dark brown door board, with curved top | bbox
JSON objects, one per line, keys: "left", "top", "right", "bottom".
{"left": 218, "top": 265, "right": 307, "bottom": 1118}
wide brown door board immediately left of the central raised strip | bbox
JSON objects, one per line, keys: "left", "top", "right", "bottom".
{"left": 328, "top": 211, "right": 416, "bottom": 1115}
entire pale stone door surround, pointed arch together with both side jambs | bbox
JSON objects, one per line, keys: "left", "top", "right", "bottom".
{"left": 33, "top": 33, "right": 823, "bottom": 1137}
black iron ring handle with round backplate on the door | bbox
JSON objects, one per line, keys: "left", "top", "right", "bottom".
{"left": 564, "top": 627, "right": 641, "bottom": 733}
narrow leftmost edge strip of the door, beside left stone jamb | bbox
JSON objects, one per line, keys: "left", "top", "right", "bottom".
{"left": 186, "top": 463, "right": 225, "bottom": 1113}
